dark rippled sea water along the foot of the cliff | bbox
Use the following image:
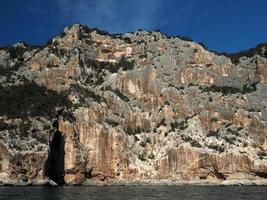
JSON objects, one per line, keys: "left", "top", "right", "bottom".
{"left": 0, "top": 186, "right": 267, "bottom": 200}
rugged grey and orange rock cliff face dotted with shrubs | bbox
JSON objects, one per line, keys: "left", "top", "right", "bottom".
{"left": 0, "top": 24, "right": 267, "bottom": 185}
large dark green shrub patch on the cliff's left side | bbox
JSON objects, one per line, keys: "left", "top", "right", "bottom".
{"left": 0, "top": 82, "right": 72, "bottom": 118}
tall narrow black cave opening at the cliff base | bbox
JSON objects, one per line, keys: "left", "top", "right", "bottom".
{"left": 45, "top": 120, "right": 65, "bottom": 185}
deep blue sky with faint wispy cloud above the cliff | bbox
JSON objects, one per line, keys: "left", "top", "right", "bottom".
{"left": 0, "top": 0, "right": 267, "bottom": 52}
